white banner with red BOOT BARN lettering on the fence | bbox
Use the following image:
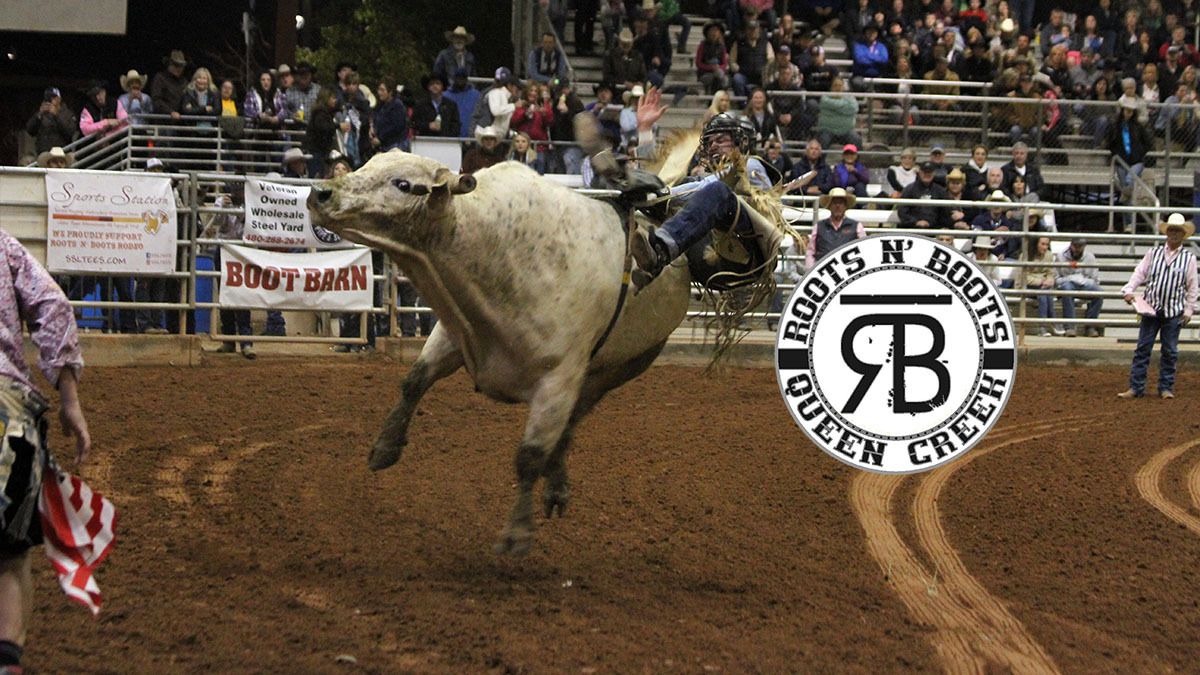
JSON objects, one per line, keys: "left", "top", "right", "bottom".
{"left": 221, "top": 244, "right": 374, "bottom": 311}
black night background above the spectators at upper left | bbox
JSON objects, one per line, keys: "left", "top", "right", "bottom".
{"left": 0, "top": 0, "right": 512, "bottom": 165}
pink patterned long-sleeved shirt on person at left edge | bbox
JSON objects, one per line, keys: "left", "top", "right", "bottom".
{"left": 0, "top": 229, "right": 83, "bottom": 389}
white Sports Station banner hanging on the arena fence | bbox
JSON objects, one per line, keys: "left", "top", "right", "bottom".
{"left": 46, "top": 171, "right": 178, "bottom": 274}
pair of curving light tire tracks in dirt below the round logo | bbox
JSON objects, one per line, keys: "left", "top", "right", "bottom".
{"left": 850, "top": 416, "right": 1087, "bottom": 673}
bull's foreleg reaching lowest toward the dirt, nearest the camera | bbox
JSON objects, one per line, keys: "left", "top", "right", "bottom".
{"left": 496, "top": 364, "right": 583, "bottom": 555}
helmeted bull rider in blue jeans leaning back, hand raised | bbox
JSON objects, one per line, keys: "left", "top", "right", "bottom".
{"left": 576, "top": 89, "right": 801, "bottom": 291}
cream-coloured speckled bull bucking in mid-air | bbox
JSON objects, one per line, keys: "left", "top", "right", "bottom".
{"left": 308, "top": 126, "right": 796, "bottom": 554}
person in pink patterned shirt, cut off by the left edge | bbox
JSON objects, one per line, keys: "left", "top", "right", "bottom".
{"left": 0, "top": 225, "right": 91, "bottom": 673}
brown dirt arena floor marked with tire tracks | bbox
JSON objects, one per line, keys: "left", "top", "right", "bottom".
{"left": 26, "top": 357, "right": 1200, "bottom": 673}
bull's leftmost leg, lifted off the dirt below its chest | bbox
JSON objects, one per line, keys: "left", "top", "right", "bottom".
{"left": 367, "top": 323, "right": 463, "bottom": 471}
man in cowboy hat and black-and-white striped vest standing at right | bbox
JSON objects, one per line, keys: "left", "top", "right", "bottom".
{"left": 1117, "top": 214, "right": 1196, "bottom": 399}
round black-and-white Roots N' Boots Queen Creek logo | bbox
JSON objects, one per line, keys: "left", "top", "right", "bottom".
{"left": 775, "top": 234, "right": 1016, "bottom": 473}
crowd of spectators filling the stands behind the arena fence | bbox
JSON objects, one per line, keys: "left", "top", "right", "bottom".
{"left": 26, "top": 0, "right": 1200, "bottom": 333}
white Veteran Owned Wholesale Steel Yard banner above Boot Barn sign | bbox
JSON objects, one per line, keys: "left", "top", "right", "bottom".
{"left": 241, "top": 179, "right": 353, "bottom": 249}
